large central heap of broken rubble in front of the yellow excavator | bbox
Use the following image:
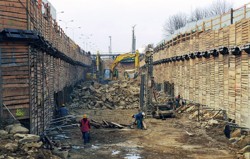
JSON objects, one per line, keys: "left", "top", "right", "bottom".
{"left": 70, "top": 80, "right": 140, "bottom": 109}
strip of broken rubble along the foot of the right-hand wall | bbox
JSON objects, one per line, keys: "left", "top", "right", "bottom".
{"left": 177, "top": 104, "right": 250, "bottom": 159}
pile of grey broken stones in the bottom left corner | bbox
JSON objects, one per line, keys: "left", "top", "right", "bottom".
{"left": 0, "top": 124, "right": 60, "bottom": 159}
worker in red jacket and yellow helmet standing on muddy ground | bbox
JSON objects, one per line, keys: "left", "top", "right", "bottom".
{"left": 80, "top": 114, "right": 90, "bottom": 145}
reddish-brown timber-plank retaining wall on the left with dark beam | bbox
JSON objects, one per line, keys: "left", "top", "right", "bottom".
{"left": 0, "top": 0, "right": 91, "bottom": 134}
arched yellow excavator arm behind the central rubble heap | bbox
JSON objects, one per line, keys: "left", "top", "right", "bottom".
{"left": 110, "top": 50, "right": 140, "bottom": 79}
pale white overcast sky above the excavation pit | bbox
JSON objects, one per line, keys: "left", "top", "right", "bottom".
{"left": 50, "top": 0, "right": 247, "bottom": 53}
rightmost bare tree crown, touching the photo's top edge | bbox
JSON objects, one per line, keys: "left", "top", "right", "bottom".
{"left": 208, "top": 0, "right": 233, "bottom": 16}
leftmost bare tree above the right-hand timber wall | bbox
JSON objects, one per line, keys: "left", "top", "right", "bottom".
{"left": 164, "top": 13, "right": 187, "bottom": 34}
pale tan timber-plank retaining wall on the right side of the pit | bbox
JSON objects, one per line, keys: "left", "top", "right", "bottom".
{"left": 146, "top": 5, "right": 250, "bottom": 128}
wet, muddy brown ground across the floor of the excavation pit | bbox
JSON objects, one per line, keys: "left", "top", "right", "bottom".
{"left": 62, "top": 109, "right": 236, "bottom": 159}
